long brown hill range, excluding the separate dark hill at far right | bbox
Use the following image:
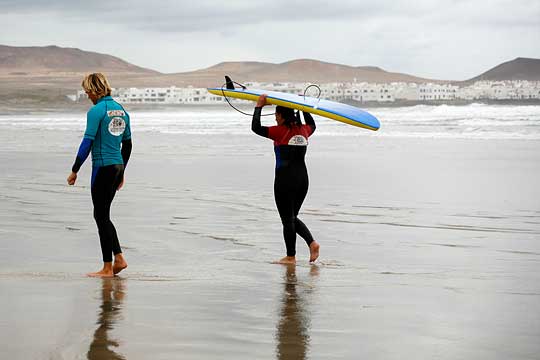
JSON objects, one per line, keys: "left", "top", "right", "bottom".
{"left": 0, "top": 45, "right": 438, "bottom": 86}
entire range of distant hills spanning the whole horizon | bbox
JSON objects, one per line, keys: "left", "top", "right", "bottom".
{"left": 0, "top": 45, "right": 540, "bottom": 97}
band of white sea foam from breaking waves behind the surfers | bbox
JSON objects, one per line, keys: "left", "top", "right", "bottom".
{"left": 0, "top": 104, "right": 540, "bottom": 140}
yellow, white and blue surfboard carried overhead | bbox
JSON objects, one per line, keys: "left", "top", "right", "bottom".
{"left": 207, "top": 82, "right": 380, "bottom": 131}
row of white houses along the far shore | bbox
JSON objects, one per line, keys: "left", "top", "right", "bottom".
{"left": 74, "top": 81, "right": 540, "bottom": 104}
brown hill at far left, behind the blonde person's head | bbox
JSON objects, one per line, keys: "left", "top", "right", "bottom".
{"left": 0, "top": 45, "right": 159, "bottom": 76}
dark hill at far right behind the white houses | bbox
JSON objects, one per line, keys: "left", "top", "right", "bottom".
{"left": 467, "top": 58, "right": 540, "bottom": 82}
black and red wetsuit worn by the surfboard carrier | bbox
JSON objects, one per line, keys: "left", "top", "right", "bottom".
{"left": 251, "top": 107, "right": 315, "bottom": 256}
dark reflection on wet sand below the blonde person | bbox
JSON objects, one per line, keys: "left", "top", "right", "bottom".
{"left": 87, "top": 278, "right": 125, "bottom": 360}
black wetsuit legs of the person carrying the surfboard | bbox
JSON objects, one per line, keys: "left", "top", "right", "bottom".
{"left": 274, "top": 164, "right": 313, "bottom": 256}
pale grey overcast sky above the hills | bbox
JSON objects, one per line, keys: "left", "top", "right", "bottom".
{"left": 0, "top": 0, "right": 540, "bottom": 80}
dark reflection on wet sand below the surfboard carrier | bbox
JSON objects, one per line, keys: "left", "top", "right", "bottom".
{"left": 276, "top": 265, "right": 319, "bottom": 360}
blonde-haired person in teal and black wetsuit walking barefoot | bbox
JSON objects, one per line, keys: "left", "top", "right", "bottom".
{"left": 67, "top": 73, "right": 132, "bottom": 277}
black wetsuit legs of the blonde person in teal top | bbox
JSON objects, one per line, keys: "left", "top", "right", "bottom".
{"left": 92, "top": 165, "right": 124, "bottom": 262}
